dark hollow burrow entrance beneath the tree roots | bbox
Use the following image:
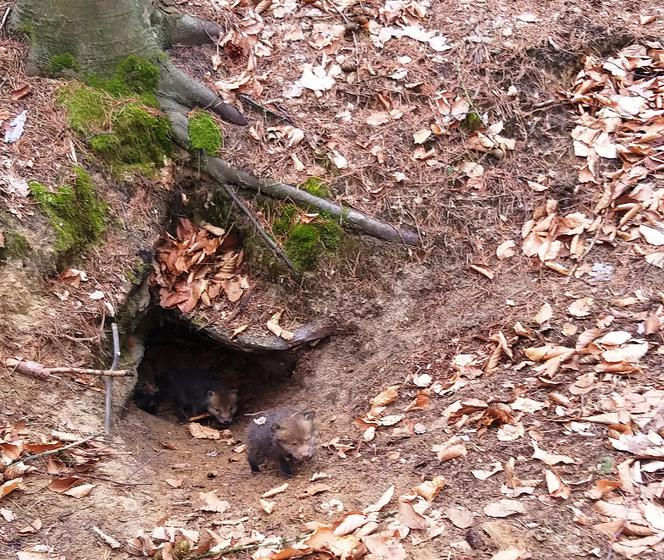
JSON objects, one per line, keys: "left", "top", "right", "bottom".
{"left": 127, "top": 306, "right": 298, "bottom": 427}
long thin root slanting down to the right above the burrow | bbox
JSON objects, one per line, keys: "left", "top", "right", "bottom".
{"left": 160, "top": 97, "right": 420, "bottom": 246}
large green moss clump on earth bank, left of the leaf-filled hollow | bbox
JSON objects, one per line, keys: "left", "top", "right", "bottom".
{"left": 30, "top": 167, "right": 108, "bottom": 254}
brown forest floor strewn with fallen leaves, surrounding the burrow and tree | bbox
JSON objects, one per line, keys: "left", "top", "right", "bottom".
{"left": 0, "top": 0, "right": 664, "bottom": 560}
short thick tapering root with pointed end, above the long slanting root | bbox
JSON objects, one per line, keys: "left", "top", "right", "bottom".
{"left": 158, "top": 62, "right": 247, "bottom": 126}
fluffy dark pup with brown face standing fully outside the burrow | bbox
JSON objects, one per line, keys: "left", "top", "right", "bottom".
{"left": 247, "top": 408, "right": 316, "bottom": 476}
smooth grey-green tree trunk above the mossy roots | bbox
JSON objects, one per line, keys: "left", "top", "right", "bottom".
{"left": 13, "top": 0, "right": 160, "bottom": 74}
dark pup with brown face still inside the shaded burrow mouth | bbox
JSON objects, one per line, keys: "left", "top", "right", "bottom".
{"left": 164, "top": 369, "right": 238, "bottom": 425}
